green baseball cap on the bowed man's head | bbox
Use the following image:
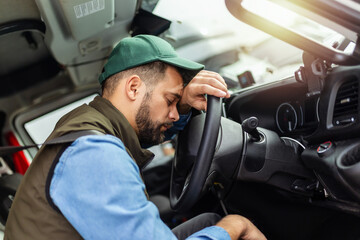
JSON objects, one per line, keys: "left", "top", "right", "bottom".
{"left": 99, "top": 35, "right": 204, "bottom": 84}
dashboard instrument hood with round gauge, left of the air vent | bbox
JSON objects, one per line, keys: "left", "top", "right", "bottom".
{"left": 227, "top": 78, "right": 320, "bottom": 140}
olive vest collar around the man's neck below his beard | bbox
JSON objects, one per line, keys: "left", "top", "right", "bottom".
{"left": 89, "top": 96, "right": 154, "bottom": 168}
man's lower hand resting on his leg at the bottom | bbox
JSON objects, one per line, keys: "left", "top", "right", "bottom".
{"left": 216, "top": 215, "right": 266, "bottom": 240}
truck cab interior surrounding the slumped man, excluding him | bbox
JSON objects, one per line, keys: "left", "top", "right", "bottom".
{"left": 0, "top": 0, "right": 360, "bottom": 240}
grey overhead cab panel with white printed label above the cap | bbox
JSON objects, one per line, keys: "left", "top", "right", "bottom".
{"left": 35, "top": 0, "right": 140, "bottom": 85}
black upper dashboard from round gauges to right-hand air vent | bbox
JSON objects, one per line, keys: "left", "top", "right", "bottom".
{"left": 226, "top": 66, "right": 360, "bottom": 144}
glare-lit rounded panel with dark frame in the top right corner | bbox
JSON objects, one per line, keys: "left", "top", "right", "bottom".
{"left": 225, "top": 0, "right": 360, "bottom": 66}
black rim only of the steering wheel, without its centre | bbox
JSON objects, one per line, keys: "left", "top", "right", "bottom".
{"left": 170, "top": 95, "right": 222, "bottom": 211}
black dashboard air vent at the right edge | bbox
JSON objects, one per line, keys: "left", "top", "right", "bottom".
{"left": 333, "top": 77, "right": 359, "bottom": 125}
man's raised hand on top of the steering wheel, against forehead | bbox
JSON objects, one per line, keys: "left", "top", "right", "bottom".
{"left": 178, "top": 70, "right": 230, "bottom": 114}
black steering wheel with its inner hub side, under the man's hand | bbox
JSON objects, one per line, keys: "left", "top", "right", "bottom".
{"left": 170, "top": 95, "right": 222, "bottom": 211}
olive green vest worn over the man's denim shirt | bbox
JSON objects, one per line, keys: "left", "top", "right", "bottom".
{"left": 4, "top": 97, "right": 154, "bottom": 240}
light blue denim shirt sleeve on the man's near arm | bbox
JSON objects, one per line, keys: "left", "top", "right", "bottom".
{"left": 50, "top": 135, "right": 227, "bottom": 240}
